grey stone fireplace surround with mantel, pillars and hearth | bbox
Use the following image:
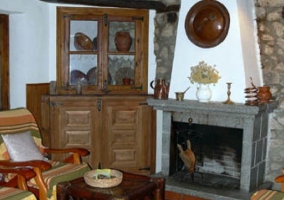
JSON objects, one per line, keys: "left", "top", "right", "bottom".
{"left": 148, "top": 99, "right": 277, "bottom": 199}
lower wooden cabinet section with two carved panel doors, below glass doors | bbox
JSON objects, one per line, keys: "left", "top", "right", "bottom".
{"left": 43, "top": 95, "right": 156, "bottom": 174}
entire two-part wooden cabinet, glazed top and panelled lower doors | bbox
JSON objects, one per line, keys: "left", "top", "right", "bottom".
{"left": 48, "top": 7, "right": 156, "bottom": 174}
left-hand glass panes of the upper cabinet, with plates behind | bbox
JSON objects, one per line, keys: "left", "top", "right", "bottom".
{"left": 69, "top": 20, "right": 98, "bottom": 85}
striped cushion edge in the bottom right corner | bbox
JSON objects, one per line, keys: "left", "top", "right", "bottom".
{"left": 250, "top": 190, "right": 284, "bottom": 200}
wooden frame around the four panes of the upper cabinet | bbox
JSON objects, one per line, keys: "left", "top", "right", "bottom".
{"left": 56, "top": 7, "right": 149, "bottom": 94}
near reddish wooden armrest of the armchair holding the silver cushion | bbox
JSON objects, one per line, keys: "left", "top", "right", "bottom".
{"left": 0, "top": 160, "right": 51, "bottom": 171}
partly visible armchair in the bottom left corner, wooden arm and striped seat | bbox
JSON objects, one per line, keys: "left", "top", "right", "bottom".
{"left": 0, "top": 168, "right": 36, "bottom": 200}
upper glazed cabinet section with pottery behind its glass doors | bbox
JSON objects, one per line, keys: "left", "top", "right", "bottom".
{"left": 57, "top": 7, "right": 149, "bottom": 94}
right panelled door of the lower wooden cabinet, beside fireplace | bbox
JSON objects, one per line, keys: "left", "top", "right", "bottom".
{"left": 102, "top": 99, "right": 154, "bottom": 174}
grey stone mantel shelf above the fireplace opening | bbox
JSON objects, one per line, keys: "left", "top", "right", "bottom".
{"left": 148, "top": 99, "right": 278, "bottom": 128}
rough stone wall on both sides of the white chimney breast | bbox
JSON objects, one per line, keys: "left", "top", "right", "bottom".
{"left": 154, "top": 0, "right": 284, "bottom": 187}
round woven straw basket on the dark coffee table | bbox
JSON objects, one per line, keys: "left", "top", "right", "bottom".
{"left": 84, "top": 169, "right": 123, "bottom": 188}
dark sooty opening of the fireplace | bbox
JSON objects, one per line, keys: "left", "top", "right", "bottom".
{"left": 169, "top": 122, "right": 243, "bottom": 189}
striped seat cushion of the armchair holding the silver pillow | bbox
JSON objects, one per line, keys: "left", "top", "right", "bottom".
{"left": 28, "top": 161, "right": 91, "bottom": 198}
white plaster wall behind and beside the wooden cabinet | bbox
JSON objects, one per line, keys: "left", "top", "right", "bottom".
{"left": 0, "top": 0, "right": 156, "bottom": 108}
